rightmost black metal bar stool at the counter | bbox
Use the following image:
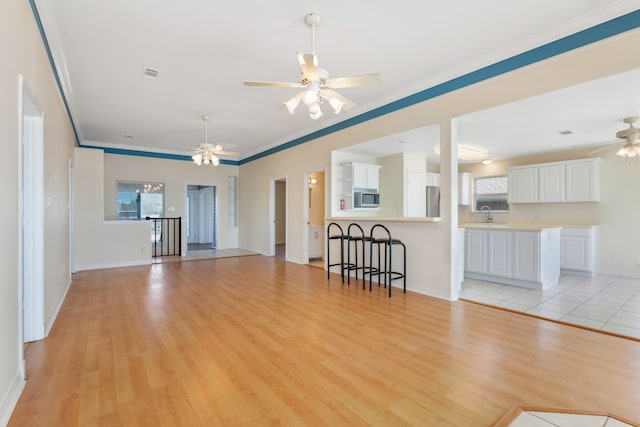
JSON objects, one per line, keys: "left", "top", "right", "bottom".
{"left": 369, "top": 224, "right": 407, "bottom": 297}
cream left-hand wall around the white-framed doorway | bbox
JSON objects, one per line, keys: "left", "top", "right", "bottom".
{"left": 0, "top": 0, "right": 74, "bottom": 425}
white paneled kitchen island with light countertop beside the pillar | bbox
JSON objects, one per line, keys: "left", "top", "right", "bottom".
{"left": 460, "top": 223, "right": 562, "bottom": 289}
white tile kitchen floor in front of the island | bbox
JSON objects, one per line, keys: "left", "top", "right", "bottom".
{"left": 460, "top": 275, "right": 640, "bottom": 338}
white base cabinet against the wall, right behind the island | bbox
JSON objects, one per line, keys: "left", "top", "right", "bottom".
{"left": 560, "top": 227, "right": 599, "bottom": 277}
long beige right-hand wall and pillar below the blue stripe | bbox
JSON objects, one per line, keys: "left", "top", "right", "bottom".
{"left": 240, "top": 30, "right": 640, "bottom": 295}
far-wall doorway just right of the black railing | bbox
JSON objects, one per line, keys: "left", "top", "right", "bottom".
{"left": 185, "top": 185, "right": 217, "bottom": 252}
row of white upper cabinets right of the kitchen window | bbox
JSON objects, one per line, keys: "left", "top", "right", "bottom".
{"left": 509, "top": 158, "right": 600, "bottom": 203}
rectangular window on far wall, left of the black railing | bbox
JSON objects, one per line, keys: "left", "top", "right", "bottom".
{"left": 116, "top": 181, "right": 164, "bottom": 219}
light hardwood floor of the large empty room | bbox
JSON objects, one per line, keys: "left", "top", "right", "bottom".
{"left": 9, "top": 256, "right": 640, "bottom": 426}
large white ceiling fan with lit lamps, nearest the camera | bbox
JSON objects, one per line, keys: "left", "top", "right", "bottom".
{"left": 244, "top": 13, "right": 382, "bottom": 120}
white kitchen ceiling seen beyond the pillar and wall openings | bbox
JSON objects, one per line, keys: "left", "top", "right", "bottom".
{"left": 341, "top": 68, "right": 640, "bottom": 164}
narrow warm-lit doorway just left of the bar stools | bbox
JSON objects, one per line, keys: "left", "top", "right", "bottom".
{"left": 306, "top": 171, "right": 325, "bottom": 268}
